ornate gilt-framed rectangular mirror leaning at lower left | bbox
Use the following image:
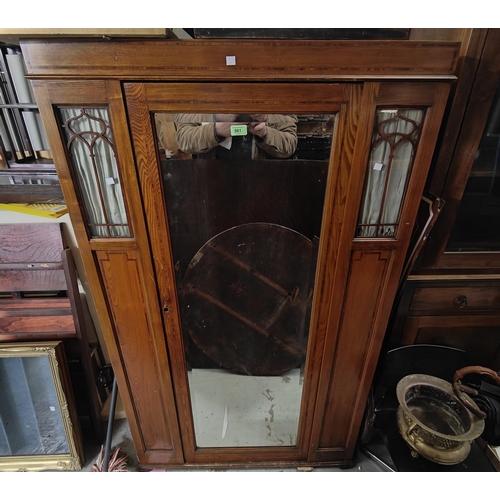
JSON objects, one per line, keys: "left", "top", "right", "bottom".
{"left": 0, "top": 342, "right": 81, "bottom": 470}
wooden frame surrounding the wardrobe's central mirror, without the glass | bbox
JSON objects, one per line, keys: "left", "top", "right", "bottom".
{"left": 124, "top": 83, "right": 369, "bottom": 463}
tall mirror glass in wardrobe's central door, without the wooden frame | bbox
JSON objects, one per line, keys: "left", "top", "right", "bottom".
{"left": 155, "top": 113, "right": 335, "bottom": 447}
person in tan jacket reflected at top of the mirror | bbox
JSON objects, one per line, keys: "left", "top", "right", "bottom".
{"left": 174, "top": 113, "right": 297, "bottom": 159}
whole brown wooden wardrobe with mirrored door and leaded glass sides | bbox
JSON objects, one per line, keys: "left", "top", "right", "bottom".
{"left": 22, "top": 40, "right": 459, "bottom": 467}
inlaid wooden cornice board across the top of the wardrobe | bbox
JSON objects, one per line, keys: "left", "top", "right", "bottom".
{"left": 21, "top": 40, "right": 460, "bottom": 81}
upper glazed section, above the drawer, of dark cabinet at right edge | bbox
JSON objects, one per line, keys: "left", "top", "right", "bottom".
{"left": 420, "top": 29, "right": 500, "bottom": 275}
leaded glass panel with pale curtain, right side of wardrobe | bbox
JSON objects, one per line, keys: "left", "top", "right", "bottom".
{"left": 357, "top": 109, "right": 425, "bottom": 238}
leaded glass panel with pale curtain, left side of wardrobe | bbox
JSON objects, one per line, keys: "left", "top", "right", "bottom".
{"left": 59, "top": 107, "right": 130, "bottom": 238}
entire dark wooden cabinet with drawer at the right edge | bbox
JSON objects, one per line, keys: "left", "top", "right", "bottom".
{"left": 390, "top": 29, "right": 500, "bottom": 370}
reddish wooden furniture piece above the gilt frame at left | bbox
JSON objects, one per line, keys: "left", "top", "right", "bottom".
{"left": 0, "top": 222, "right": 108, "bottom": 440}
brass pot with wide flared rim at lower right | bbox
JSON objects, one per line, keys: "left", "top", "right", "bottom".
{"left": 396, "top": 374, "right": 484, "bottom": 465}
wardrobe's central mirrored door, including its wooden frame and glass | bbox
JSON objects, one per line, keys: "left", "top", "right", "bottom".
{"left": 126, "top": 84, "right": 356, "bottom": 461}
